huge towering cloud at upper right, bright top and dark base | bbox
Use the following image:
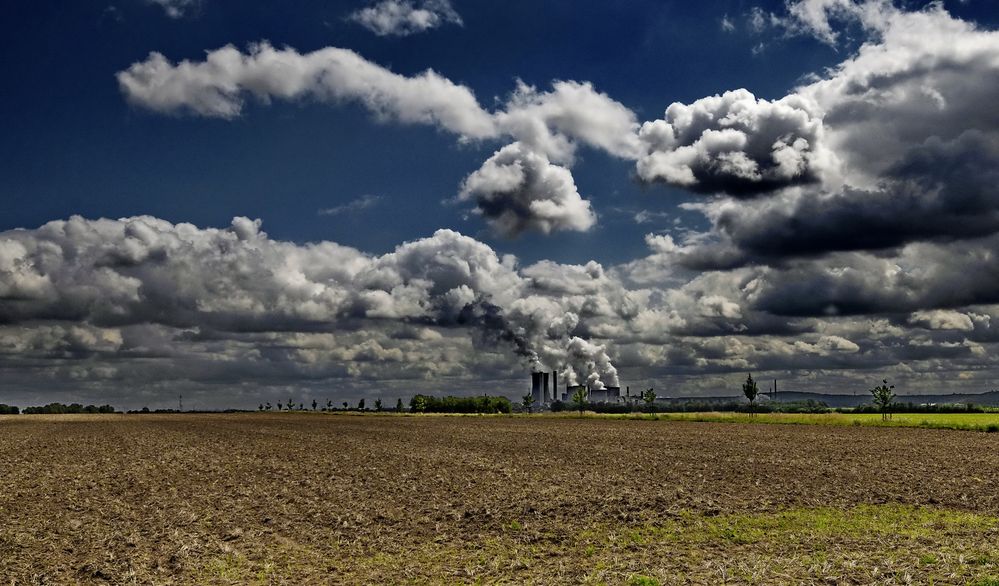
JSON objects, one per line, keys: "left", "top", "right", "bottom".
{"left": 664, "top": 2, "right": 999, "bottom": 269}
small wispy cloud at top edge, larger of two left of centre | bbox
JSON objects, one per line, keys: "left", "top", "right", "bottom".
{"left": 348, "top": 0, "right": 462, "bottom": 36}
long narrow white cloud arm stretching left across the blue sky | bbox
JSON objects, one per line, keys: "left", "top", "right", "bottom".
{"left": 117, "top": 43, "right": 496, "bottom": 138}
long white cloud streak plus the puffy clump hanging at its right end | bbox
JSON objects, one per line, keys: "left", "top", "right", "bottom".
{"left": 118, "top": 43, "right": 642, "bottom": 235}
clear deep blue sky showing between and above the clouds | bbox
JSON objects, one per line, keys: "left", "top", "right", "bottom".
{"left": 0, "top": 0, "right": 880, "bottom": 262}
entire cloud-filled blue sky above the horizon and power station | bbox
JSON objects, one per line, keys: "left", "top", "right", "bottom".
{"left": 0, "top": 0, "right": 999, "bottom": 409}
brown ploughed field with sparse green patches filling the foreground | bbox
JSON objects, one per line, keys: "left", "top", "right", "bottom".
{"left": 0, "top": 413, "right": 999, "bottom": 584}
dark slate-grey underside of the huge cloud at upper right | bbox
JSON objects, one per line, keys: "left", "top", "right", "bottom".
{"left": 683, "top": 130, "right": 999, "bottom": 269}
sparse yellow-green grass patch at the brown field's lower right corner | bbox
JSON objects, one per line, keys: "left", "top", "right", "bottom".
{"left": 336, "top": 504, "right": 999, "bottom": 586}
